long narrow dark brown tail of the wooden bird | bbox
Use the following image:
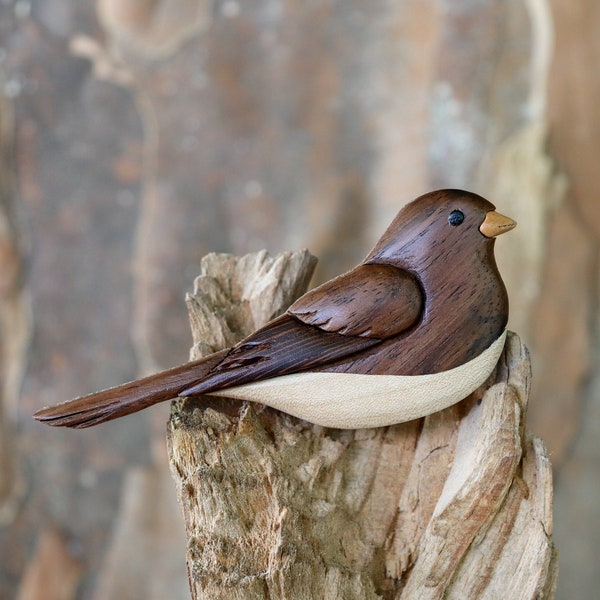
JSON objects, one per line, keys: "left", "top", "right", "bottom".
{"left": 33, "top": 350, "right": 226, "bottom": 429}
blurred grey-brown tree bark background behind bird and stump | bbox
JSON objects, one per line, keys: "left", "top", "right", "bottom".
{"left": 0, "top": 0, "right": 600, "bottom": 600}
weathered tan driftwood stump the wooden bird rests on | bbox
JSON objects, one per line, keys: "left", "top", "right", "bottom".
{"left": 168, "top": 252, "right": 557, "bottom": 600}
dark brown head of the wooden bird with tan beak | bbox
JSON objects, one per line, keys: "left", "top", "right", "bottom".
{"left": 366, "top": 190, "right": 516, "bottom": 271}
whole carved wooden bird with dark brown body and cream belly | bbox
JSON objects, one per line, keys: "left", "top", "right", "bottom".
{"left": 34, "top": 190, "right": 516, "bottom": 428}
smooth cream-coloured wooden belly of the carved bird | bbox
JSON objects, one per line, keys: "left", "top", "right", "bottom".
{"left": 211, "top": 331, "right": 506, "bottom": 429}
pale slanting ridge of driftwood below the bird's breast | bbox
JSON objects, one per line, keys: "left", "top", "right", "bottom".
{"left": 404, "top": 384, "right": 521, "bottom": 598}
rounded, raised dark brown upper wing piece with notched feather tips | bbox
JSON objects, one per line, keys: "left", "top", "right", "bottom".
{"left": 288, "top": 264, "right": 424, "bottom": 339}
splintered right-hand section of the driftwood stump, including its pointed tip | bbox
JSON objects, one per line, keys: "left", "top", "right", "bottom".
{"left": 401, "top": 333, "right": 557, "bottom": 599}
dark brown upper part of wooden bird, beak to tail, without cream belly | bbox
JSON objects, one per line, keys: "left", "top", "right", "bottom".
{"left": 35, "top": 190, "right": 515, "bottom": 427}
